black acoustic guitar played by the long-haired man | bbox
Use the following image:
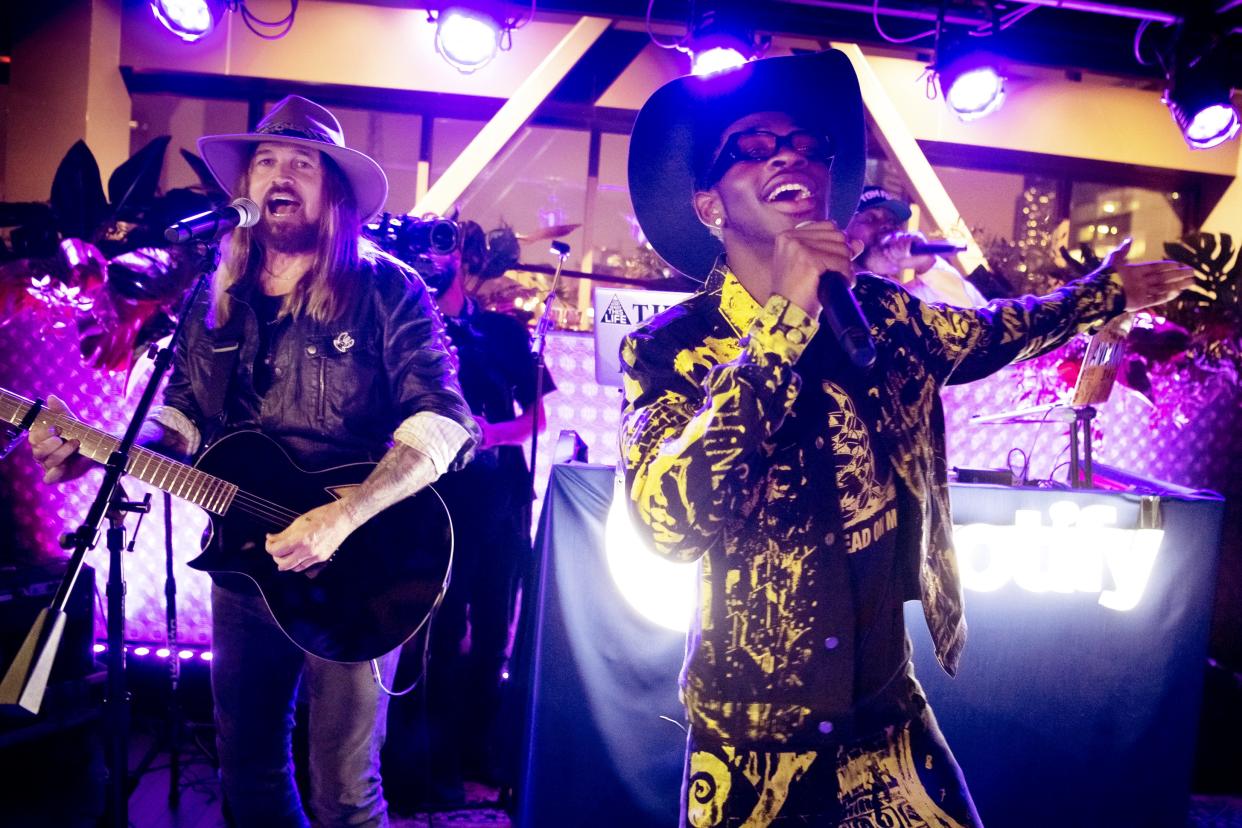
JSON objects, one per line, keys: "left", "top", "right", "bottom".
{"left": 0, "top": 389, "right": 453, "bottom": 662}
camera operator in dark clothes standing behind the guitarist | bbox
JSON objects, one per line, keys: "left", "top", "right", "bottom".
{"left": 394, "top": 221, "right": 556, "bottom": 809}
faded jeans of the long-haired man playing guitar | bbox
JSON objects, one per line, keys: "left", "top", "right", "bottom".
{"left": 211, "top": 586, "right": 397, "bottom": 828}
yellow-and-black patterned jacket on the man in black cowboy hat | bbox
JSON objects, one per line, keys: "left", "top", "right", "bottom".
{"left": 621, "top": 266, "right": 1124, "bottom": 741}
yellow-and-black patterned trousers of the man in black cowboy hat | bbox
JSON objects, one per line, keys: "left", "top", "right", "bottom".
{"left": 681, "top": 699, "right": 982, "bottom": 828}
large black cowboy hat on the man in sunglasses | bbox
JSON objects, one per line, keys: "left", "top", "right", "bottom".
{"left": 630, "top": 50, "right": 866, "bottom": 279}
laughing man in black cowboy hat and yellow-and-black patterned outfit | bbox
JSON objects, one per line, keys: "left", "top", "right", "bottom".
{"left": 621, "top": 51, "right": 1192, "bottom": 827}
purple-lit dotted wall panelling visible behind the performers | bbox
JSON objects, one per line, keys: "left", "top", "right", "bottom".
{"left": 0, "top": 323, "right": 1242, "bottom": 643}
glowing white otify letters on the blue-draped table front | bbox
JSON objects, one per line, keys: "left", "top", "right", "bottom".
{"left": 954, "top": 500, "right": 1164, "bottom": 611}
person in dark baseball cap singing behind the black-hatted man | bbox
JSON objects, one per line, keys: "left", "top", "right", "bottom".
{"left": 846, "top": 185, "right": 987, "bottom": 308}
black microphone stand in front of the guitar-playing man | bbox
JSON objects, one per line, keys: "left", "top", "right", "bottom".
{"left": 0, "top": 244, "right": 219, "bottom": 828}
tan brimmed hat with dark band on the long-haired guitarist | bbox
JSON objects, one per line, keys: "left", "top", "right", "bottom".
{"left": 199, "top": 94, "right": 388, "bottom": 223}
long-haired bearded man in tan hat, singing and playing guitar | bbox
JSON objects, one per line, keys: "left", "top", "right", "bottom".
{"left": 31, "top": 96, "right": 478, "bottom": 828}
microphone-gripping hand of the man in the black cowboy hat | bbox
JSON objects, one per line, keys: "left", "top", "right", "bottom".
{"left": 771, "top": 221, "right": 862, "bottom": 317}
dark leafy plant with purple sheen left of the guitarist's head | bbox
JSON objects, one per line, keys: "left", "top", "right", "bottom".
{"left": 0, "top": 135, "right": 224, "bottom": 370}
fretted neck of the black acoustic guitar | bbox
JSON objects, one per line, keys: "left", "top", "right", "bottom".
{"left": 0, "top": 389, "right": 237, "bottom": 515}
